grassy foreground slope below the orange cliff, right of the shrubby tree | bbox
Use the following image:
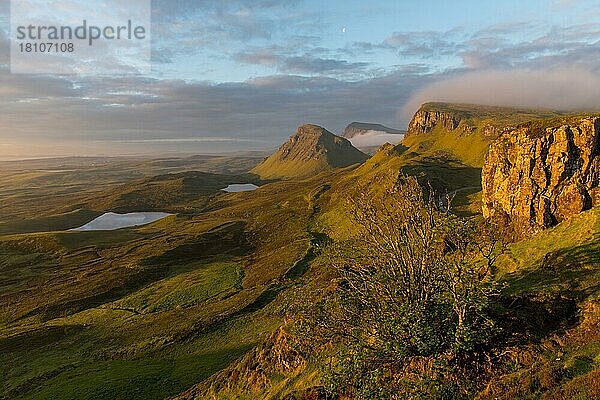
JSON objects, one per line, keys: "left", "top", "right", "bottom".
{"left": 481, "top": 207, "right": 600, "bottom": 399}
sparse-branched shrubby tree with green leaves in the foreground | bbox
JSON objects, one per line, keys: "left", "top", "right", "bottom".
{"left": 297, "top": 177, "right": 502, "bottom": 399}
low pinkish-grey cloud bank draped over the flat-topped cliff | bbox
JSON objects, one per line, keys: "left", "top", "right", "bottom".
{"left": 401, "top": 67, "right": 600, "bottom": 118}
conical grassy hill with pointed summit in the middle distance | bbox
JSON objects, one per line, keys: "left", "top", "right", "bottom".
{"left": 251, "top": 124, "right": 368, "bottom": 179}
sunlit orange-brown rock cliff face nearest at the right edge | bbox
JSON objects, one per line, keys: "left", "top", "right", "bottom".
{"left": 482, "top": 116, "right": 600, "bottom": 234}
